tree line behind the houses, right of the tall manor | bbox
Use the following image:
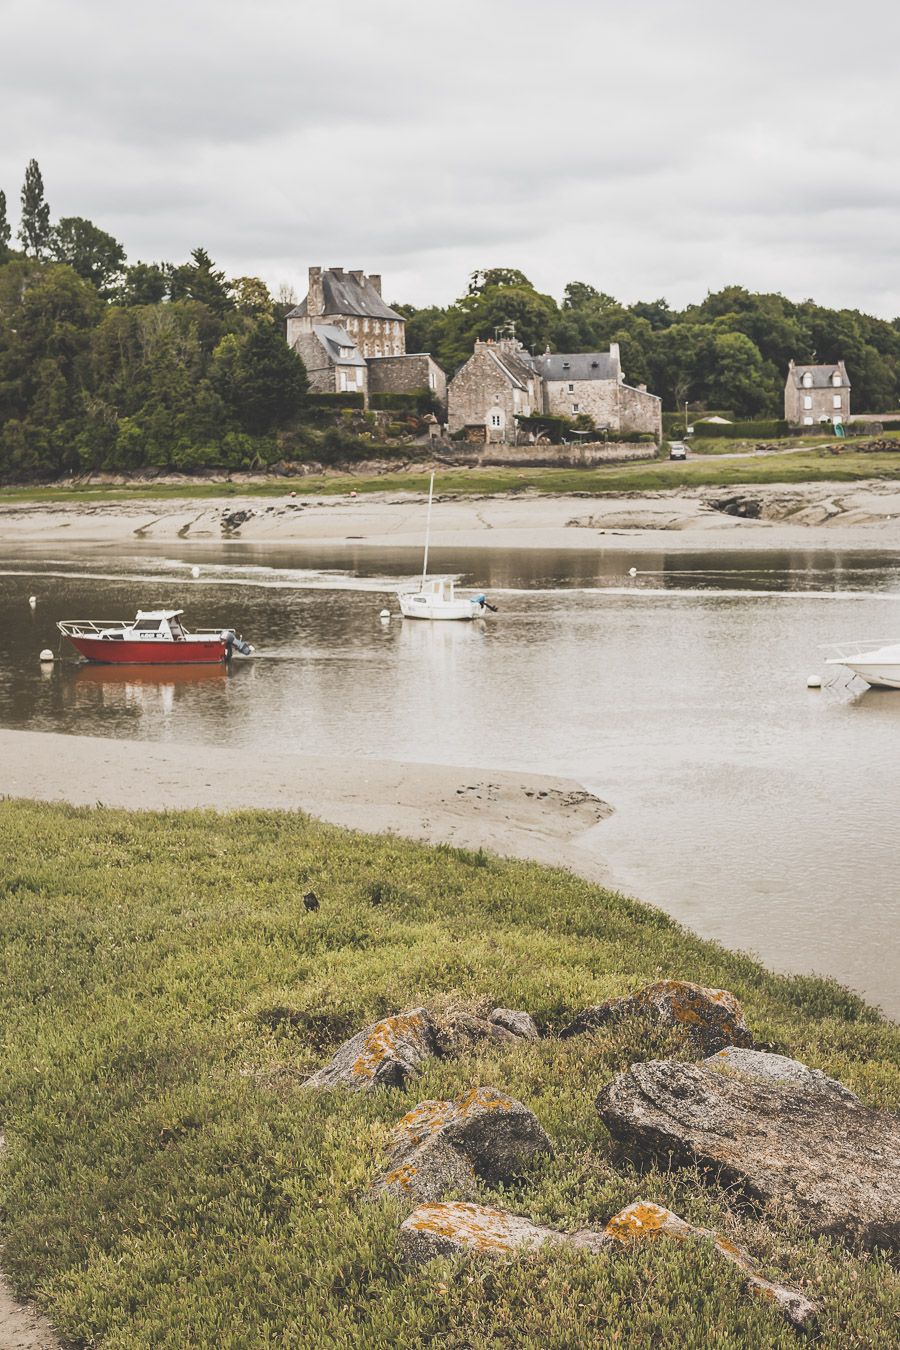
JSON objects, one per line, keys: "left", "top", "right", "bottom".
{"left": 397, "top": 267, "right": 900, "bottom": 419}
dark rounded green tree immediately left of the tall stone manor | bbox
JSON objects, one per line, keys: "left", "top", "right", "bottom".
{"left": 212, "top": 319, "right": 309, "bottom": 435}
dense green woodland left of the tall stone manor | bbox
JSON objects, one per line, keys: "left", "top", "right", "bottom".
{"left": 0, "top": 159, "right": 308, "bottom": 478}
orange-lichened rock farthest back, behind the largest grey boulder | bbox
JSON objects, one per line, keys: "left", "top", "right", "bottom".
{"left": 560, "top": 980, "right": 753, "bottom": 1056}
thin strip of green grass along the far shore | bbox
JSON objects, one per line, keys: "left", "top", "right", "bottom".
{"left": 0, "top": 441, "right": 900, "bottom": 508}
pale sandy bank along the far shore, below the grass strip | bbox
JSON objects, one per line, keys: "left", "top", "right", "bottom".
{"left": 0, "top": 482, "right": 900, "bottom": 551}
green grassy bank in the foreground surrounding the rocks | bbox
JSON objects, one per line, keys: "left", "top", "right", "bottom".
{"left": 0, "top": 802, "right": 900, "bottom": 1350}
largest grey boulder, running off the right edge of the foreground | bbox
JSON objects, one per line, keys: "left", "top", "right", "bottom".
{"left": 596, "top": 1060, "right": 900, "bottom": 1247}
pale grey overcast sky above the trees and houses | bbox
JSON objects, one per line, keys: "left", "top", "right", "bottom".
{"left": 0, "top": 0, "right": 900, "bottom": 317}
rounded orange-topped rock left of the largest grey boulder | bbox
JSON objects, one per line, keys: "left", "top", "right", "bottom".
{"left": 375, "top": 1087, "right": 553, "bottom": 1202}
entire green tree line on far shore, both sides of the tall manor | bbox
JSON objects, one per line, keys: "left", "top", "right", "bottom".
{"left": 0, "top": 159, "right": 900, "bottom": 478}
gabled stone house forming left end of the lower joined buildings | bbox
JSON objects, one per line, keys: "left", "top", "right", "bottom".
{"left": 447, "top": 338, "right": 544, "bottom": 441}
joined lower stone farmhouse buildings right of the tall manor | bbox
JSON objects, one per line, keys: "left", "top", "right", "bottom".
{"left": 448, "top": 338, "right": 663, "bottom": 441}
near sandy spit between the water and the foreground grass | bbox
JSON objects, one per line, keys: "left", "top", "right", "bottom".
{"left": 0, "top": 730, "right": 611, "bottom": 882}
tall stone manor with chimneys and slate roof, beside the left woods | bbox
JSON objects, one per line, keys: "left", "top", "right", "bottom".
{"left": 287, "top": 267, "right": 447, "bottom": 408}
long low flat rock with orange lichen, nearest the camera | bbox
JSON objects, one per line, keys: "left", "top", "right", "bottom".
{"left": 398, "top": 1200, "right": 816, "bottom": 1327}
